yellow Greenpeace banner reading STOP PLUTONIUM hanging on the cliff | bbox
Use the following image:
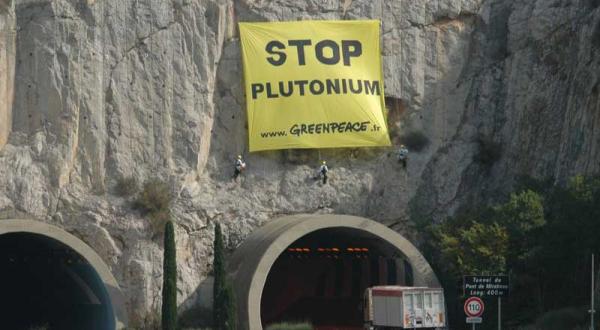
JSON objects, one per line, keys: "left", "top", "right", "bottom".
{"left": 239, "top": 21, "right": 390, "bottom": 151}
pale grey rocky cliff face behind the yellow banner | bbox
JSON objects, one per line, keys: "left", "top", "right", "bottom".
{"left": 0, "top": 0, "right": 600, "bottom": 323}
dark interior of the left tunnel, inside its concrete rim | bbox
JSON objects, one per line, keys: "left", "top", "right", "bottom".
{"left": 0, "top": 233, "right": 115, "bottom": 330}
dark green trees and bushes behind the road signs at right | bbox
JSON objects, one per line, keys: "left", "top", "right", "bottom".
{"left": 424, "top": 176, "right": 600, "bottom": 328}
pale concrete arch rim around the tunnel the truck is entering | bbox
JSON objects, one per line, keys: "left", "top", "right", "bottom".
{"left": 228, "top": 214, "right": 441, "bottom": 330}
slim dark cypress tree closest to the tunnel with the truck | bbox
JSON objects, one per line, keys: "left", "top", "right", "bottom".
{"left": 213, "top": 223, "right": 227, "bottom": 330}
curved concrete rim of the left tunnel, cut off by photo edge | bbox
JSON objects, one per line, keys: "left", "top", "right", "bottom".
{"left": 0, "top": 219, "right": 128, "bottom": 329}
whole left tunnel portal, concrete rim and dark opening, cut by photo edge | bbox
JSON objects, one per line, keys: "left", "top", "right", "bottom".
{"left": 0, "top": 219, "right": 127, "bottom": 330}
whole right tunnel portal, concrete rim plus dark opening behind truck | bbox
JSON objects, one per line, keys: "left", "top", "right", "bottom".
{"left": 229, "top": 214, "right": 440, "bottom": 330}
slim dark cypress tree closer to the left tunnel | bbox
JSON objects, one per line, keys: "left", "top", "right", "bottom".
{"left": 162, "top": 221, "right": 177, "bottom": 330}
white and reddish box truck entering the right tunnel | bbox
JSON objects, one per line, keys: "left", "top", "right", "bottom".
{"left": 363, "top": 285, "right": 446, "bottom": 330}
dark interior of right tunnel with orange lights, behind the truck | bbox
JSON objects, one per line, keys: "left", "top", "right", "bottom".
{"left": 260, "top": 227, "right": 413, "bottom": 329}
